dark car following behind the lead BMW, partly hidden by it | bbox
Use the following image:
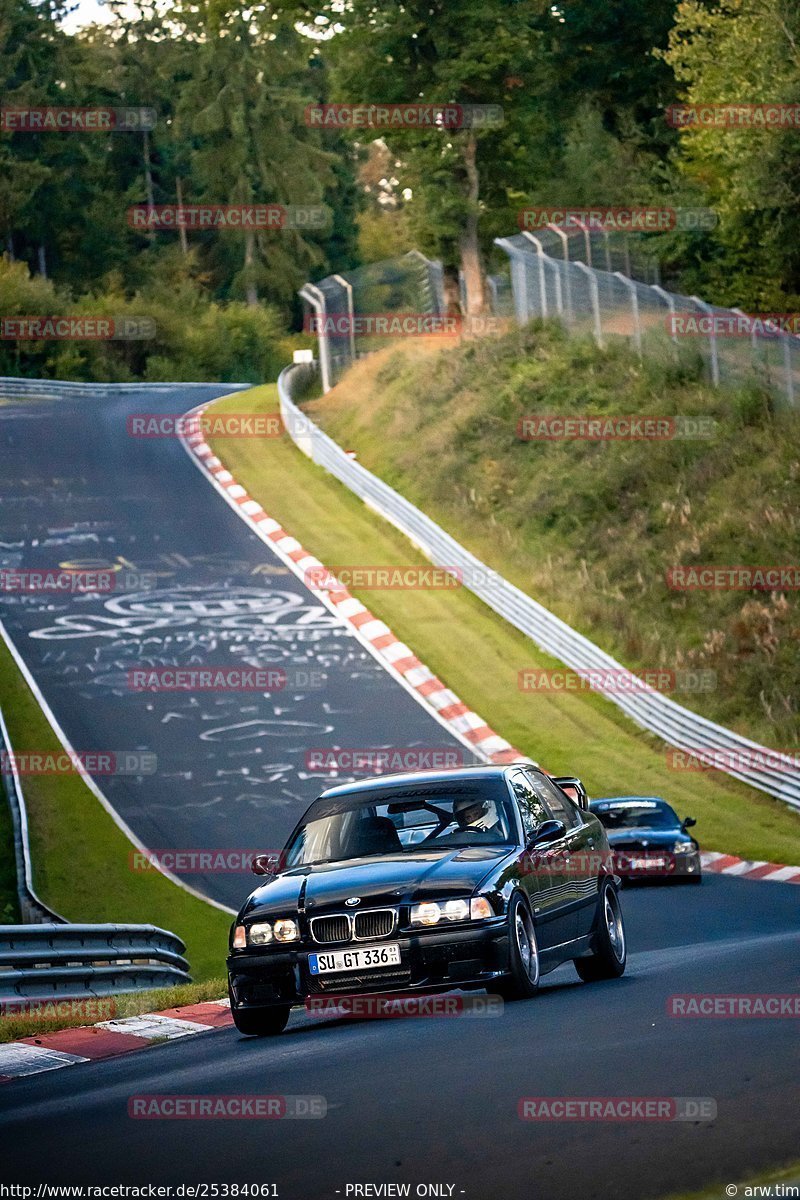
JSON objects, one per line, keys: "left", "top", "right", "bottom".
{"left": 589, "top": 796, "right": 703, "bottom": 883}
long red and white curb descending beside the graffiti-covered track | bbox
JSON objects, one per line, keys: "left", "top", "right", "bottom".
{"left": 181, "top": 404, "right": 522, "bottom": 763}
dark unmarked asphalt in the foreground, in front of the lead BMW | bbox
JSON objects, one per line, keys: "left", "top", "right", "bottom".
{"left": 0, "top": 876, "right": 800, "bottom": 1200}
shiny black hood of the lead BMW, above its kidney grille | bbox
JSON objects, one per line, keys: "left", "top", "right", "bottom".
{"left": 240, "top": 846, "right": 513, "bottom": 919}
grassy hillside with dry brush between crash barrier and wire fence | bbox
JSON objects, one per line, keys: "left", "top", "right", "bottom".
{"left": 303, "top": 328, "right": 800, "bottom": 749}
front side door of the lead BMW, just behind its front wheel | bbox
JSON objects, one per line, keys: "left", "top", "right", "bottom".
{"left": 510, "top": 770, "right": 577, "bottom": 950}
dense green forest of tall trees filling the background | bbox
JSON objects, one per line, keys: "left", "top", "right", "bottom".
{"left": 0, "top": 0, "right": 800, "bottom": 379}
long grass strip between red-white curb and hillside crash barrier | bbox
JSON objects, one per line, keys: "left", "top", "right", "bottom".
{"left": 210, "top": 384, "right": 800, "bottom": 863}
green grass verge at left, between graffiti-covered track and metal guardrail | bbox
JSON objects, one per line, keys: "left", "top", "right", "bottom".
{"left": 0, "top": 642, "right": 230, "bottom": 979}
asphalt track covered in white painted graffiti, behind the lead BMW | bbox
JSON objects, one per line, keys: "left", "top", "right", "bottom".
{"left": 0, "top": 384, "right": 474, "bottom": 908}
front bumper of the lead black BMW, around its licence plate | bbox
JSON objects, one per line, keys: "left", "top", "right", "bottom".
{"left": 228, "top": 919, "right": 509, "bottom": 1009}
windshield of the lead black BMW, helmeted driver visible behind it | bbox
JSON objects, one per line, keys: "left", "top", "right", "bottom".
{"left": 284, "top": 779, "right": 515, "bottom": 868}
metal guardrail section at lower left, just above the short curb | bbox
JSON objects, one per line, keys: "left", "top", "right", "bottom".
{"left": 0, "top": 924, "right": 190, "bottom": 1004}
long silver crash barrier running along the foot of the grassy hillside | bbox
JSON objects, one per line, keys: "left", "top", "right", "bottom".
{"left": 278, "top": 364, "right": 800, "bottom": 809}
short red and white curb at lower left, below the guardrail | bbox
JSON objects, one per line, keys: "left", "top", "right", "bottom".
{"left": 0, "top": 1000, "right": 234, "bottom": 1082}
